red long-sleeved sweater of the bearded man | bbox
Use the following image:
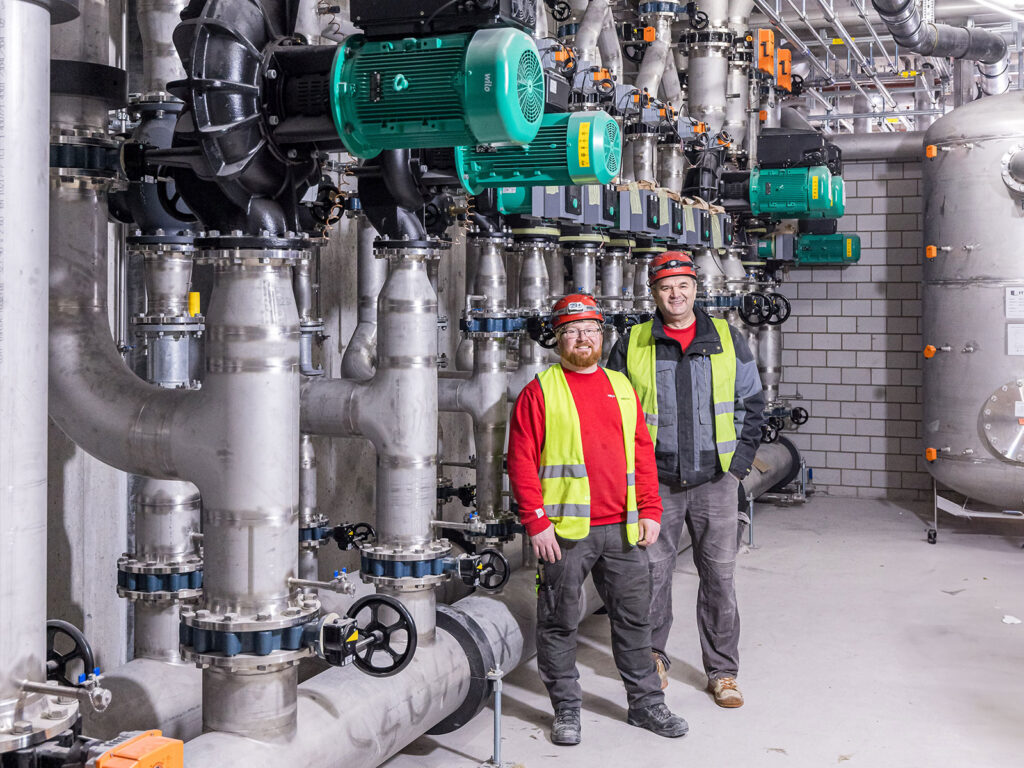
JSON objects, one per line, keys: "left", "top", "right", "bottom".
{"left": 508, "top": 369, "right": 662, "bottom": 536}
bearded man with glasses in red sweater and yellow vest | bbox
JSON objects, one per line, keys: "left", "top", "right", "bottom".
{"left": 508, "top": 294, "right": 688, "bottom": 744}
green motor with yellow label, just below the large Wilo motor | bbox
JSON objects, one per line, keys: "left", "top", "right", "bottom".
{"left": 455, "top": 112, "right": 623, "bottom": 195}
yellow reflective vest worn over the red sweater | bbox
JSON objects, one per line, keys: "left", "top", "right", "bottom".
{"left": 537, "top": 364, "right": 640, "bottom": 545}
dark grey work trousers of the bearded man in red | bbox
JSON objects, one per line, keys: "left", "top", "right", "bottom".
{"left": 537, "top": 525, "right": 665, "bottom": 712}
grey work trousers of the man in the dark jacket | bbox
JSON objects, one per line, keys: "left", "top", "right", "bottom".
{"left": 647, "top": 472, "right": 739, "bottom": 680}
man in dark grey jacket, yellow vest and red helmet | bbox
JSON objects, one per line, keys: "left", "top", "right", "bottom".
{"left": 608, "top": 251, "right": 765, "bottom": 708}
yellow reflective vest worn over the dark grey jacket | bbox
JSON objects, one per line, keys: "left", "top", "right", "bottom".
{"left": 626, "top": 317, "right": 736, "bottom": 472}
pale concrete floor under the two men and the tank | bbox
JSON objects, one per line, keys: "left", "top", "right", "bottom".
{"left": 385, "top": 497, "right": 1024, "bottom": 768}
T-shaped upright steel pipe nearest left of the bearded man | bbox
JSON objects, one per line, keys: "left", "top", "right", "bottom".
{"left": 301, "top": 249, "right": 437, "bottom": 638}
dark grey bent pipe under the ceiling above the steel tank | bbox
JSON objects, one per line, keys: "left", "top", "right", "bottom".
{"left": 871, "top": 0, "right": 1010, "bottom": 95}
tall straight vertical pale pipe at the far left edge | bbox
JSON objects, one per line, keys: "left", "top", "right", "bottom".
{"left": 0, "top": 0, "right": 61, "bottom": 752}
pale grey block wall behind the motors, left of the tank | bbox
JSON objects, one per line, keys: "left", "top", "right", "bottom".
{"left": 781, "top": 163, "right": 931, "bottom": 499}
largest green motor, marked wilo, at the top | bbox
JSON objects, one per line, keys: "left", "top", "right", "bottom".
{"left": 330, "top": 28, "right": 545, "bottom": 158}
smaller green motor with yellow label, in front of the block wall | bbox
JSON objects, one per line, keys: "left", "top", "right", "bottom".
{"left": 750, "top": 165, "right": 840, "bottom": 219}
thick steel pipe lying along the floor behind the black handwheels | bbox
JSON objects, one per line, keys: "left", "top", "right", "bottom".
{"left": 185, "top": 568, "right": 601, "bottom": 768}
